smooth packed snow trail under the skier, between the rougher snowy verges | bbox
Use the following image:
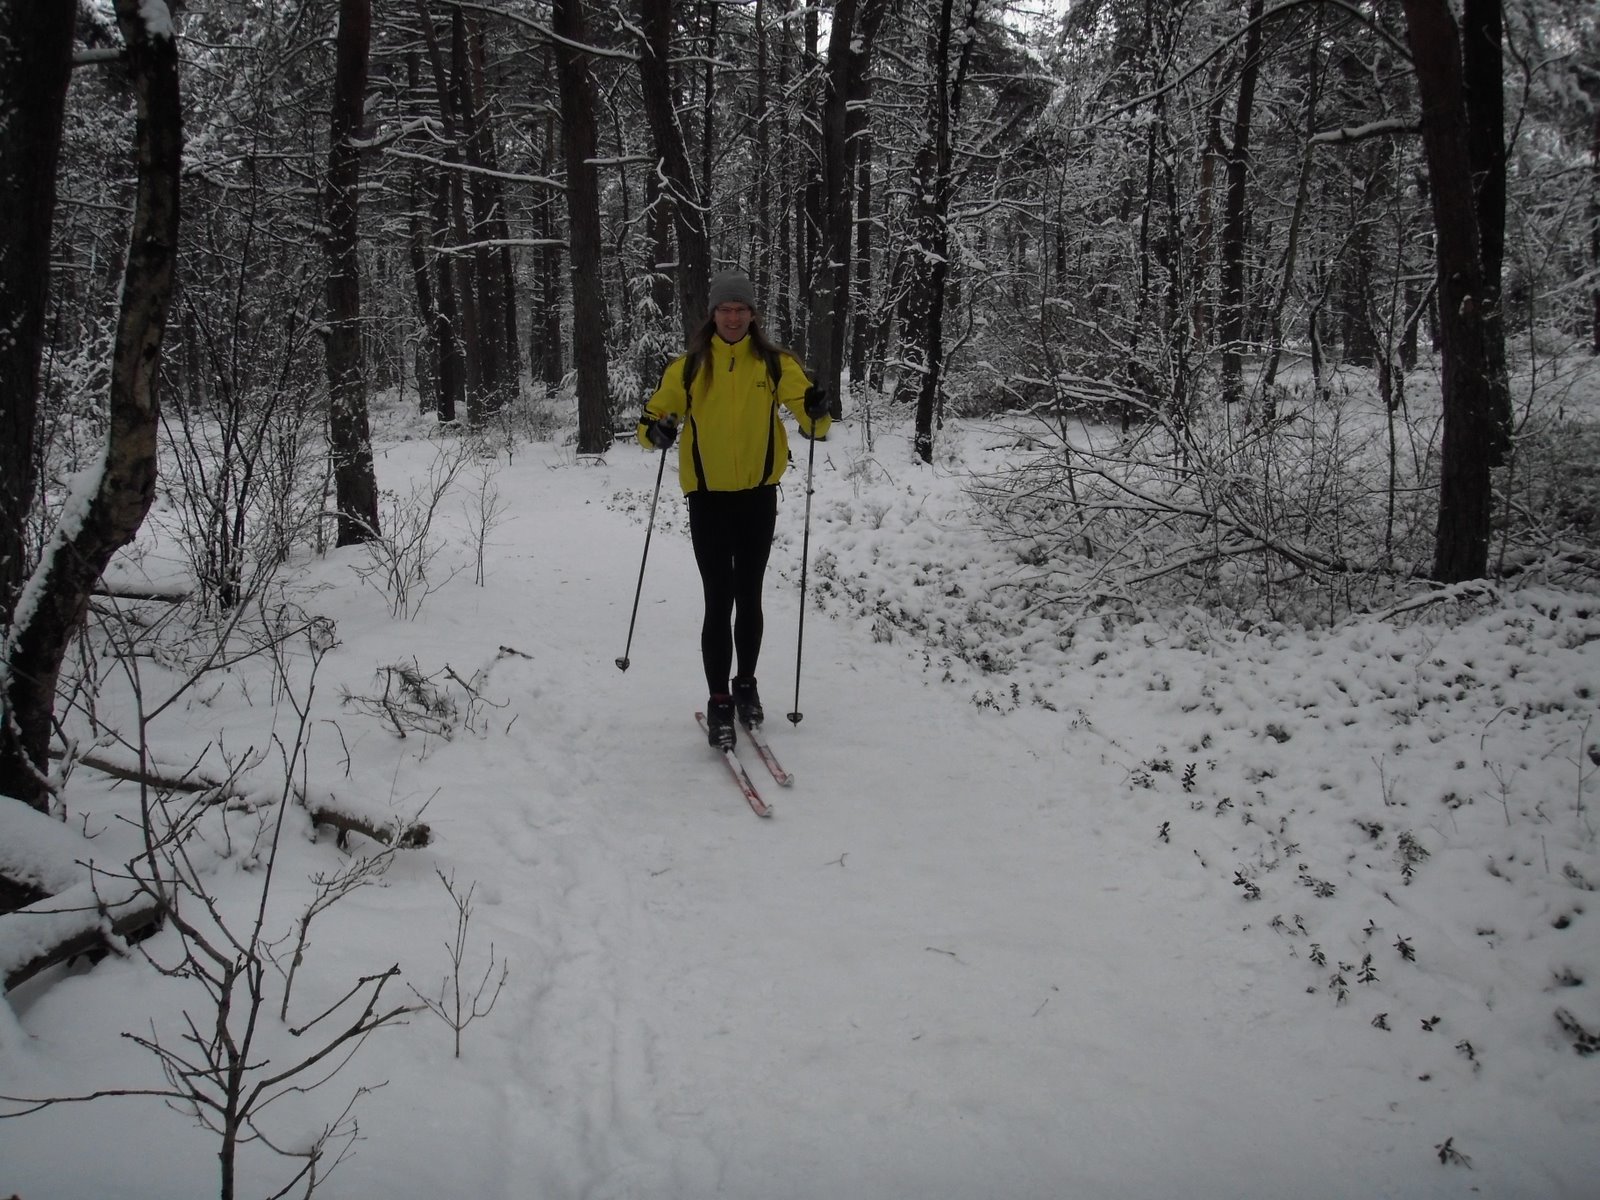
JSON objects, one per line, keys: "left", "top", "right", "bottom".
{"left": 305, "top": 438, "right": 1555, "bottom": 1200}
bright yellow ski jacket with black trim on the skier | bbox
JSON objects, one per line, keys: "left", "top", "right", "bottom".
{"left": 638, "top": 334, "right": 832, "bottom": 493}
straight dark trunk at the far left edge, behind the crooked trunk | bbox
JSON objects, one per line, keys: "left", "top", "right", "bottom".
{"left": 0, "top": 0, "right": 77, "bottom": 626}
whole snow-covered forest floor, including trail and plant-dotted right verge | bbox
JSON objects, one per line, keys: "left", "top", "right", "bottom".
{"left": 0, "top": 400, "right": 1600, "bottom": 1200}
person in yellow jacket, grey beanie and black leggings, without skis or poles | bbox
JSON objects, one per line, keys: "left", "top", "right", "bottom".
{"left": 638, "top": 270, "right": 830, "bottom": 749}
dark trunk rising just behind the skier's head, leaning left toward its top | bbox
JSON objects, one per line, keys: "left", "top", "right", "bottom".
{"left": 640, "top": 0, "right": 710, "bottom": 338}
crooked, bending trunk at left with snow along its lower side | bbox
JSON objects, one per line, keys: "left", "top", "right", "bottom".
{"left": 0, "top": 0, "right": 182, "bottom": 811}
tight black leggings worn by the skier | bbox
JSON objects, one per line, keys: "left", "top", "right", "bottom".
{"left": 686, "top": 485, "right": 778, "bottom": 696}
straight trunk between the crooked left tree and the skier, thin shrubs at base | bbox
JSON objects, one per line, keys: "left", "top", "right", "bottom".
{"left": 328, "top": 0, "right": 378, "bottom": 546}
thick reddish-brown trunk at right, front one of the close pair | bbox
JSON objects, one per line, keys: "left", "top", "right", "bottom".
{"left": 1405, "top": 0, "right": 1509, "bottom": 584}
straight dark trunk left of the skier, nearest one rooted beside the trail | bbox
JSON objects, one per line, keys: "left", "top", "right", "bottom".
{"left": 550, "top": 0, "right": 611, "bottom": 454}
